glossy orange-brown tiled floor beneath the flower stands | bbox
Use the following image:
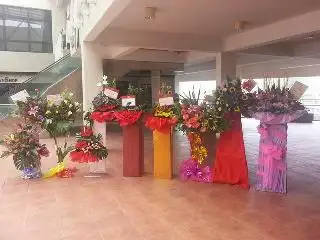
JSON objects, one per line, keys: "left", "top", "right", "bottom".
{"left": 0, "top": 120, "right": 320, "bottom": 240}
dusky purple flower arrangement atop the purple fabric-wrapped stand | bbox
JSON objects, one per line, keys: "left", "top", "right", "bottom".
{"left": 243, "top": 81, "right": 305, "bottom": 114}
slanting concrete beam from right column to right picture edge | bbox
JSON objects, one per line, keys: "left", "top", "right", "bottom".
{"left": 223, "top": 10, "right": 320, "bottom": 52}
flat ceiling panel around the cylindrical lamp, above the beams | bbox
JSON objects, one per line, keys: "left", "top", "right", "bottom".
{"left": 111, "top": 0, "right": 320, "bottom": 38}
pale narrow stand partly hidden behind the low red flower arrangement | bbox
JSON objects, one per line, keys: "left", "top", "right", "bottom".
{"left": 89, "top": 121, "right": 107, "bottom": 173}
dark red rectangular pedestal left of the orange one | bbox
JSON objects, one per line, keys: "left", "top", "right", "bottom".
{"left": 123, "top": 121, "right": 144, "bottom": 177}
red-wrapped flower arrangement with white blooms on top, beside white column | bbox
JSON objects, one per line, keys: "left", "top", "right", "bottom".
{"left": 89, "top": 75, "right": 120, "bottom": 122}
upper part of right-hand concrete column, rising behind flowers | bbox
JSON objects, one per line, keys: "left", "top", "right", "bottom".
{"left": 216, "top": 52, "right": 237, "bottom": 86}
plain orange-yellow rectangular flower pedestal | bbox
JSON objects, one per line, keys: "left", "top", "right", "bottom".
{"left": 153, "top": 130, "right": 173, "bottom": 179}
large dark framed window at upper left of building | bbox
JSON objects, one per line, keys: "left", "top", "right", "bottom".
{"left": 0, "top": 5, "right": 52, "bottom": 53}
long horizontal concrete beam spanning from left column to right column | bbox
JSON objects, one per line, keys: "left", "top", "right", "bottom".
{"left": 96, "top": 28, "right": 221, "bottom": 52}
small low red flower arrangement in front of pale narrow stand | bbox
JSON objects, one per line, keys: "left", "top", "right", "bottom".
{"left": 70, "top": 126, "right": 108, "bottom": 163}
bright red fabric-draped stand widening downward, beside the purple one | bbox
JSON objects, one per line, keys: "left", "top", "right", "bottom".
{"left": 213, "top": 112, "right": 249, "bottom": 189}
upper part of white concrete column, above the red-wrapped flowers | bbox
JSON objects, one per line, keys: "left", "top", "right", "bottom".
{"left": 81, "top": 42, "right": 103, "bottom": 111}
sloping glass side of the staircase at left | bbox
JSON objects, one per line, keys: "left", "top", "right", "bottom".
{"left": 0, "top": 54, "right": 81, "bottom": 120}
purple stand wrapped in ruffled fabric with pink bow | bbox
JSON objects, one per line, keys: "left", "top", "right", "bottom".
{"left": 253, "top": 111, "right": 305, "bottom": 193}
